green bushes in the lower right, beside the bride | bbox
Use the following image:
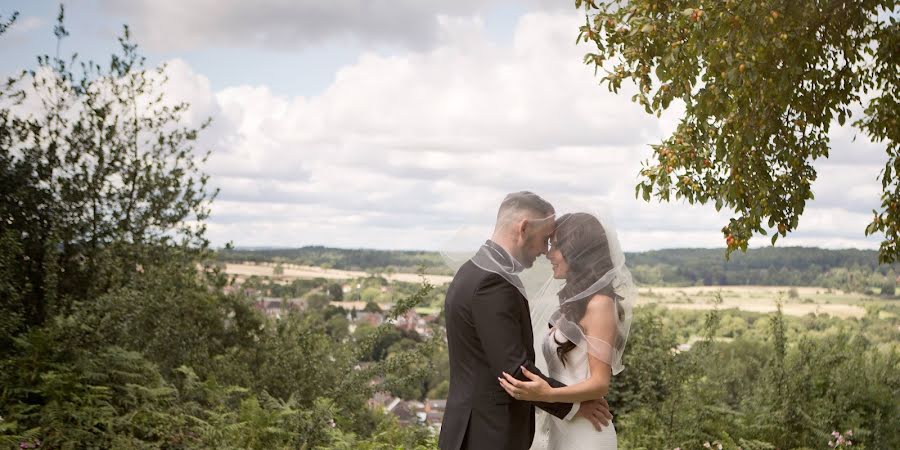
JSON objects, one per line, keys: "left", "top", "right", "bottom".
{"left": 609, "top": 307, "right": 900, "bottom": 449}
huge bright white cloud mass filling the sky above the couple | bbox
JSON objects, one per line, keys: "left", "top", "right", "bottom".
{"left": 149, "top": 13, "right": 880, "bottom": 251}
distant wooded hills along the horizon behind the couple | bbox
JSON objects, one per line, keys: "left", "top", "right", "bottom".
{"left": 218, "top": 246, "right": 896, "bottom": 292}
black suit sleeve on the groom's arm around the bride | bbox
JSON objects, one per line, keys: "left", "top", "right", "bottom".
{"left": 472, "top": 276, "right": 573, "bottom": 419}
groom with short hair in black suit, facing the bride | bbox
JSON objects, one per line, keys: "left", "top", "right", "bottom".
{"left": 439, "top": 191, "right": 612, "bottom": 450}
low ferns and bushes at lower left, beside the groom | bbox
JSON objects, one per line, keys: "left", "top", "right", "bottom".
{"left": 0, "top": 253, "right": 439, "bottom": 448}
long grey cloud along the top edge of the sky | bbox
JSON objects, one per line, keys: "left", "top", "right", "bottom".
{"left": 103, "top": 0, "right": 528, "bottom": 50}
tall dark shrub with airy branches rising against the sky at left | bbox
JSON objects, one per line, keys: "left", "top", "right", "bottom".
{"left": 0, "top": 7, "right": 215, "bottom": 334}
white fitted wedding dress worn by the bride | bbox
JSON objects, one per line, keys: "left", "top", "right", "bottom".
{"left": 531, "top": 329, "right": 618, "bottom": 450}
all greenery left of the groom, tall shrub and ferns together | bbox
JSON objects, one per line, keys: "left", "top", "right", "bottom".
{"left": 0, "top": 8, "right": 440, "bottom": 449}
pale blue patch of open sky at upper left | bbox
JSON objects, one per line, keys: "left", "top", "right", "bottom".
{"left": 0, "top": 0, "right": 370, "bottom": 96}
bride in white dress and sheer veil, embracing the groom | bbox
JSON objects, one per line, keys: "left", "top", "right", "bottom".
{"left": 499, "top": 213, "right": 636, "bottom": 450}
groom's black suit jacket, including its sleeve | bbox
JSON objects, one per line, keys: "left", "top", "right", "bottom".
{"left": 439, "top": 248, "right": 572, "bottom": 450}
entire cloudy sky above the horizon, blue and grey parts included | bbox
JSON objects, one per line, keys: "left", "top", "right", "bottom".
{"left": 0, "top": 0, "right": 886, "bottom": 251}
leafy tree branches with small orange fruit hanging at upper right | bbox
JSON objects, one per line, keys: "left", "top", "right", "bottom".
{"left": 576, "top": 0, "right": 900, "bottom": 262}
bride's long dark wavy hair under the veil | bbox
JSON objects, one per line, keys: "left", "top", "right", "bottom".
{"left": 554, "top": 213, "right": 624, "bottom": 365}
